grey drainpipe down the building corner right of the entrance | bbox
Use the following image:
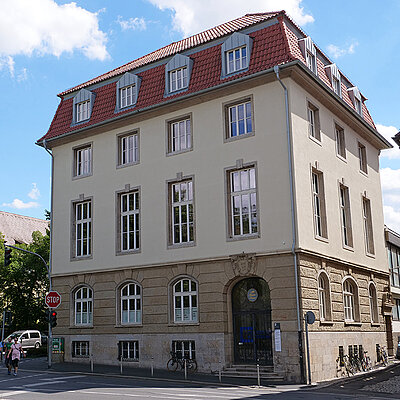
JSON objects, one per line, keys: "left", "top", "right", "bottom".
{"left": 274, "top": 65, "right": 305, "bottom": 382}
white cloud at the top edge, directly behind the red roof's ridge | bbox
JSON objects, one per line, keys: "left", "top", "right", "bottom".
{"left": 148, "top": 0, "right": 314, "bottom": 37}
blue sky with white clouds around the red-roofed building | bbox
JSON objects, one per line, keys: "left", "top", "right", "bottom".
{"left": 0, "top": 0, "right": 400, "bottom": 232}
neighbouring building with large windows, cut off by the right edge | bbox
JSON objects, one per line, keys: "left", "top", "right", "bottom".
{"left": 385, "top": 227, "right": 400, "bottom": 350}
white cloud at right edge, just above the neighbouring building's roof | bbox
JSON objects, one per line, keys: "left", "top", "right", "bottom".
{"left": 380, "top": 168, "right": 400, "bottom": 232}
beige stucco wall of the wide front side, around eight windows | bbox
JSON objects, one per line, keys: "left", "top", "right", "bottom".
{"left": 53, "top": 82, "right": 291, "bottom": 275}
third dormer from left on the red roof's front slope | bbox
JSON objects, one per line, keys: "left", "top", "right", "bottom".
{"left": 164, "top": 54, "right": 193, "bottom": 96}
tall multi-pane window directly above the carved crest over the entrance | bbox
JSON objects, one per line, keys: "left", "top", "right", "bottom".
{"left": 229, "top": 167, "right": 258, "bottom": 237}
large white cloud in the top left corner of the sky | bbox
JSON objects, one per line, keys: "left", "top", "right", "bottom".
{"left": 0, "top": 0, "right": 109, "bottom": 66}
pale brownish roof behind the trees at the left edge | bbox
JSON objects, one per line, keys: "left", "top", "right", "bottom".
{"left": 0, "top": 211, "right": 49, "bottom": 245}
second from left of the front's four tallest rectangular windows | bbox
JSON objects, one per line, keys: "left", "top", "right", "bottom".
{"left": 119, "top": 190, "right": 140, "bottom": 251}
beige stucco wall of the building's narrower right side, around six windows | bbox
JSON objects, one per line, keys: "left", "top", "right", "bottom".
{"left": 286, "top": 80, "right": 388, "bottom": 271}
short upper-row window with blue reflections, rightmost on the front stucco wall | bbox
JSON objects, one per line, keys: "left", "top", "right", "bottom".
{"left": 226, "top": 101, "right": 253, "bottom": 139}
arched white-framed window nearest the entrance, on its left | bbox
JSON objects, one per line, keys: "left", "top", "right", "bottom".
{"left": 173, "top": 278, "right": 198, "bottom": 322}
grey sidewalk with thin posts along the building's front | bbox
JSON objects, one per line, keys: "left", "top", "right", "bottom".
{"left": 21, "top": 357, "right": 309, "bottom": 390}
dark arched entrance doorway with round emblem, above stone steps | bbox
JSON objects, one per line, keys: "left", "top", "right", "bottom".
{"left": 232, "top": 278, "right": 273, "bottom": 365}
